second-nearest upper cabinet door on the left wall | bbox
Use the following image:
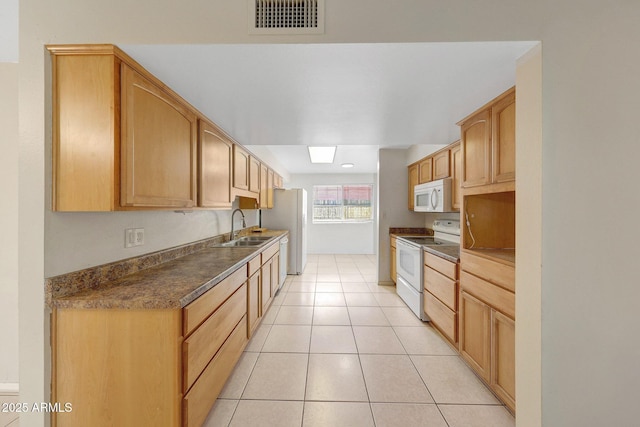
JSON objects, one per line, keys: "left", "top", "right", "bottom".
{"left": 198, "top": 120, "right": 233, "bottom": 208}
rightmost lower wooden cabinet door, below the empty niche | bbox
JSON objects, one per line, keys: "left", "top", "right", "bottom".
{"left": 490, "top": 310, "right": 516, "bottom": 410}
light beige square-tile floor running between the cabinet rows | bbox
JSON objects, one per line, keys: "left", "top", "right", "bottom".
{"left": 205, "top": 255, "right": 515, "bottom": 427}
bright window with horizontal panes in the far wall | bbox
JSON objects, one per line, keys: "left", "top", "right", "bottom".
{"left": 313, "top": 184, "right": 373, "bottom": 223}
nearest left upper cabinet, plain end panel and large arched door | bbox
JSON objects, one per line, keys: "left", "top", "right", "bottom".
{"left": 48, "top": 45, "right": 197, "bottom": 211}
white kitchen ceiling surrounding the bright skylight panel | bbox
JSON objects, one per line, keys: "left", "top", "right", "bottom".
{"left": 120, "top": 42, "right": 534, "bottom": 173}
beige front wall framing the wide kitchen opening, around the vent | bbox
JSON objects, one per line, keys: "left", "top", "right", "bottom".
{"left": 13, "top": 0, "right": 640, "bottom": 426}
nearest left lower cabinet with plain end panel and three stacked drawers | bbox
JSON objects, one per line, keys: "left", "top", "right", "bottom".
{"left": 51, "top": 262, "right": 255, "bottom": 427}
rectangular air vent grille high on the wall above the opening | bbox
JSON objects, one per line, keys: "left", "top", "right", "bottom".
{"left": 248, "top": 0, "right": 324, "bottom": 34}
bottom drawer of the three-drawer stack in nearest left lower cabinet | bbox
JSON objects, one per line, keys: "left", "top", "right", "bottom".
{"left": 182, "top": 317, "right": 247, "bottom": 427}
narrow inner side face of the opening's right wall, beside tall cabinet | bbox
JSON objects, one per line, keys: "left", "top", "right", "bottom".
{"left": 516, "top": 45, "right": 542, "bottom": 426}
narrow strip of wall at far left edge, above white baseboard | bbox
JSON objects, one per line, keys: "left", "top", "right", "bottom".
{"left": 0, "top": 64, "right": 18, "bottom": 391}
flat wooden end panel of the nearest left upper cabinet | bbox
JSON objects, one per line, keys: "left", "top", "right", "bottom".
{"left": 51, "top": 54, "right": 120, "bottom": 211}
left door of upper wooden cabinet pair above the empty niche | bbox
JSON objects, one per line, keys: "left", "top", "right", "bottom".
{"left": 460, "top": 110, "right": 491, "bottom": 188}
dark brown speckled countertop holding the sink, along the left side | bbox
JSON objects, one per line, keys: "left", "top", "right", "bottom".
{"left": 51, "top": 230, "right": 287, "bottom": 309}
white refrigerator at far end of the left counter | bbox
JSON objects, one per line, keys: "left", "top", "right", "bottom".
{"left": 261, "top": 188, "right": 307, "bottom": 274}
